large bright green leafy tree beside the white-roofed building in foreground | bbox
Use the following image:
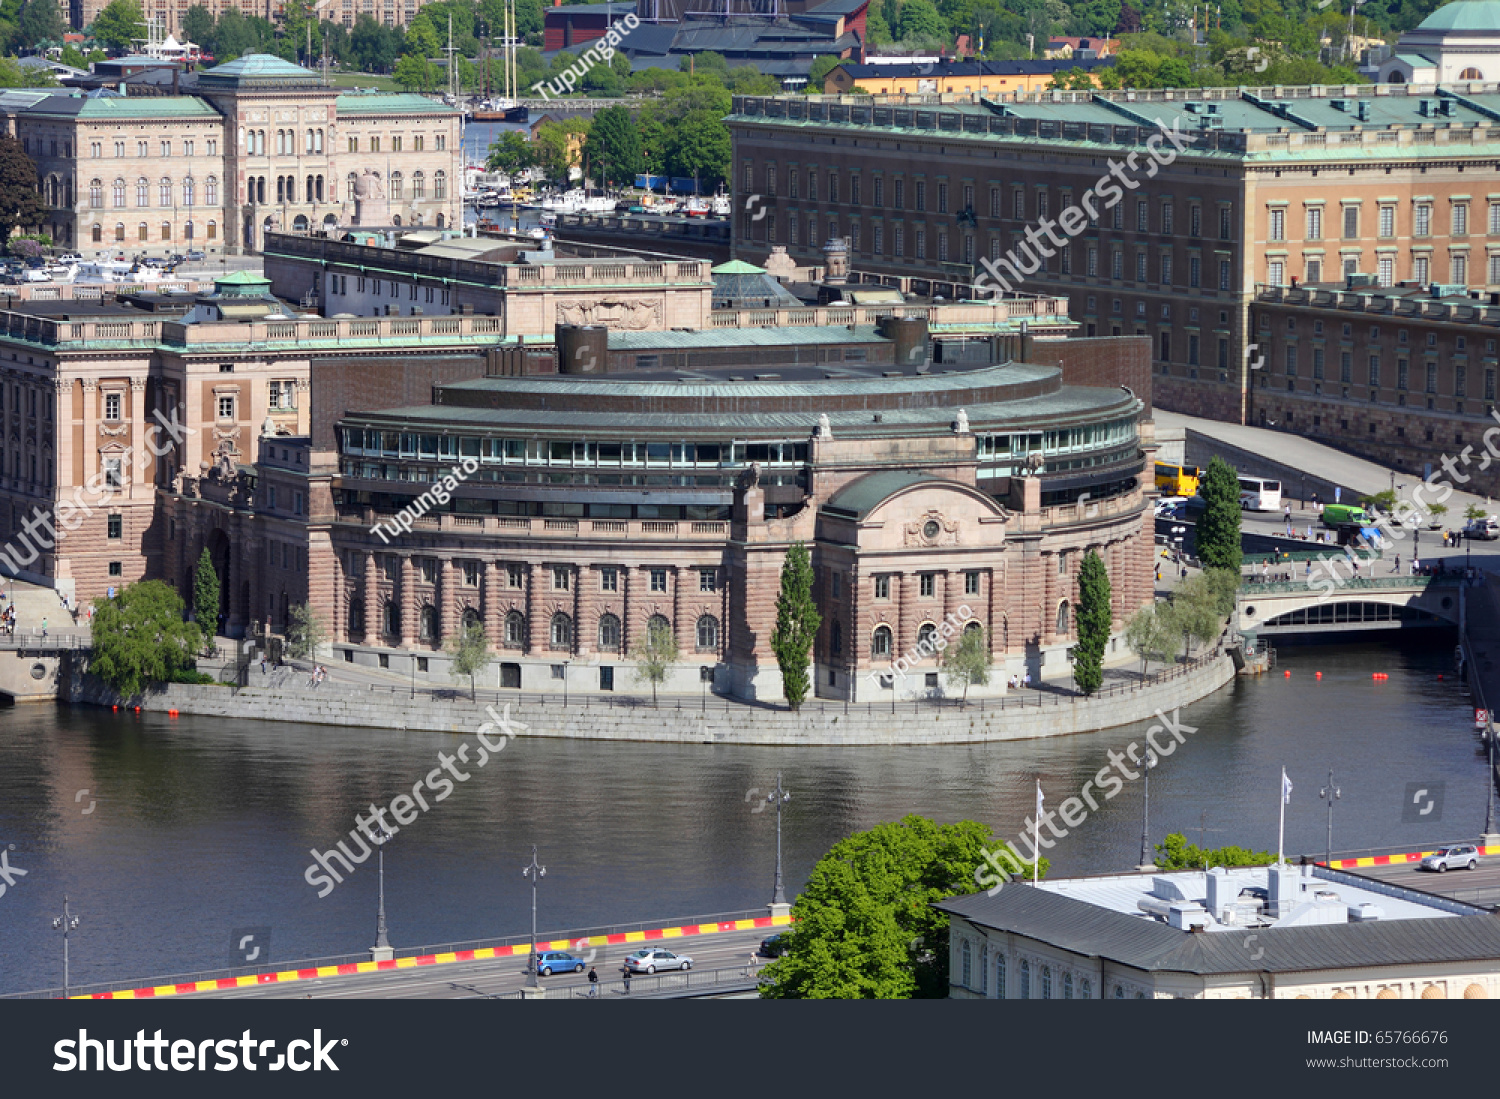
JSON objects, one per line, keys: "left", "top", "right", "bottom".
{"left": 761, "top": 816, "right": 1020, "bottom": 1000}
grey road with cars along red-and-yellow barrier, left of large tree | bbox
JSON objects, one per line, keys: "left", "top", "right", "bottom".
{"left": 191, "top": 928, "right": 774, "bottom": 1000}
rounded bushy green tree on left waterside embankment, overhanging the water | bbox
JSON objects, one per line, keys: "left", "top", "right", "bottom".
{"left": 89, "top": 580, "right": 203, "bottom": 697}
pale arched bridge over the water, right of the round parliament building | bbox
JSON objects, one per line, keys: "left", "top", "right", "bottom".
{"left": 1235, "top": 570, "right": 1463, "bottom": 637}
